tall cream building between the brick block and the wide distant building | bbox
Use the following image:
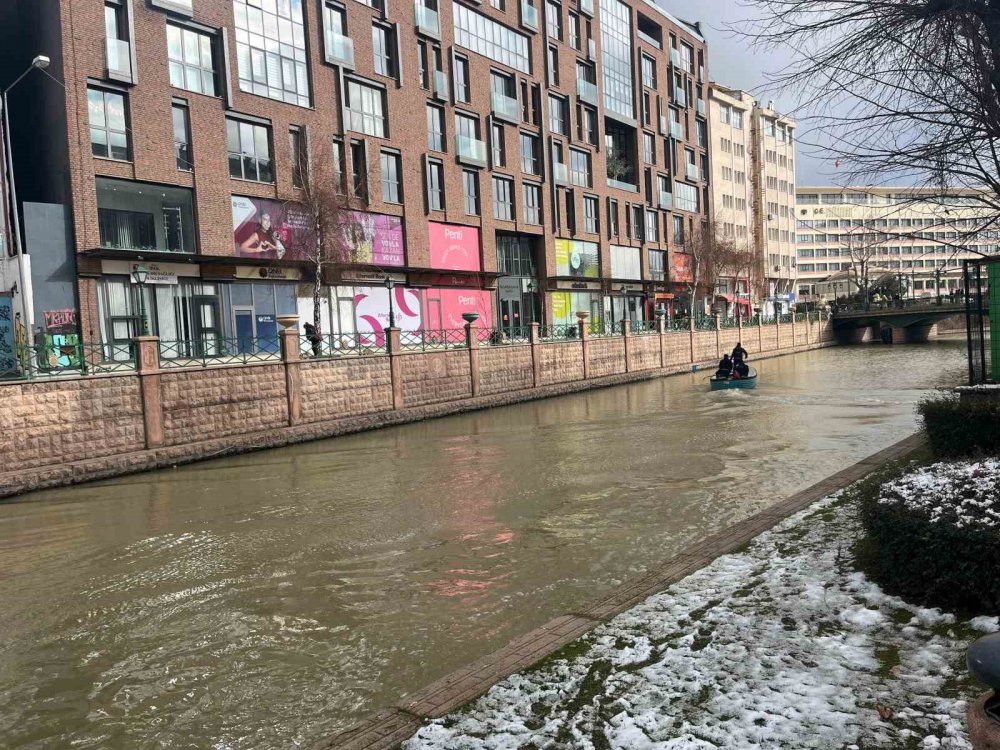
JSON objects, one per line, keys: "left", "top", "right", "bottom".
{"left": 709, "top": 81, "right": 796, "bottom": 313}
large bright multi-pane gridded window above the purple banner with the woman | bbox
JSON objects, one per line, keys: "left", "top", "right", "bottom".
{"left": 233, "top": 0, "right": 310, "bottom": 107}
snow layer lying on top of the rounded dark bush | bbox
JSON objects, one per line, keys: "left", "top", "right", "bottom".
{"left": 879, "top": 458, "right": 1000, "bottom": 529}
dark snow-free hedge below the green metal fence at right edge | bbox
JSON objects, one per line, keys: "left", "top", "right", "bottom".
{"left": 917, "top": 393, "right": 1000, "bottom": 458}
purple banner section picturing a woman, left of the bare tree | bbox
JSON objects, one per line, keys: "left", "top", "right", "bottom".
{"left": 232, "top": 195, "right": 315, "bottom": 260}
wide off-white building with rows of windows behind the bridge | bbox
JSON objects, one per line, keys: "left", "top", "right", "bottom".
{"left": 795, "top": 187, "right": 1000, "bottom": 300}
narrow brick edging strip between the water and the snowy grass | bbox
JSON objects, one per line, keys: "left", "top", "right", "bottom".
{"left": 314, "top": 433, "right": 924, "bottom": 750}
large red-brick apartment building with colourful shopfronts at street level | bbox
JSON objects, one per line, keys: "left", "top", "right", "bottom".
{"left": 0, "top": 0, "right": 710, "bottom": 356}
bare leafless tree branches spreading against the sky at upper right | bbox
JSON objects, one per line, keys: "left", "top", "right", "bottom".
{"left": 736, "top": 0, "right": 1000, "bottom": 235}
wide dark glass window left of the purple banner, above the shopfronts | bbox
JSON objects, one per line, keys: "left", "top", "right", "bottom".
{"left": 97, "top": 177, "right": 196, "bottom": 253}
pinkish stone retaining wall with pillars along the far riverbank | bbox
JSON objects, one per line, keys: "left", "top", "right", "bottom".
{"left": 0, "top": 320, "right": 834, "bottom": 497}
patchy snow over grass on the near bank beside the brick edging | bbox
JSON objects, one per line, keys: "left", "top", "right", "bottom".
{"left": 404, "top": 499, "right": 998, "bottom": 750}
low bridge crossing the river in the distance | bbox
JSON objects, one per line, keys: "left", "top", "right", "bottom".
{"left": 833, "top": 298, "right": 965, "bottom": 344}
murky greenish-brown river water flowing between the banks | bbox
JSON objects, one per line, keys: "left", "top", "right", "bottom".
{"left": 0, "top": 339, "right": 965, "bottom": 750}
